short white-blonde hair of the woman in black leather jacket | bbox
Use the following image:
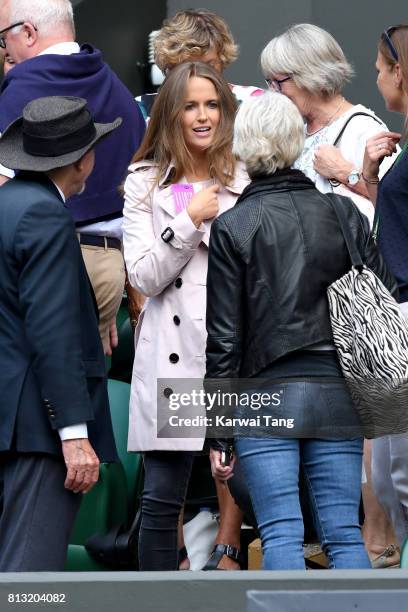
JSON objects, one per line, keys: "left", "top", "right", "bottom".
{"left": 232, "top": 91, "right": 305, "bottom": 176}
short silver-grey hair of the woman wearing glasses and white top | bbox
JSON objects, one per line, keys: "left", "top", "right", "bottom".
{"left": 261, "top": 23, "right": 354, "bottom": 97}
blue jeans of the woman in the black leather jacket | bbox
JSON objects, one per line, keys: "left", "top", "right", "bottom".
{"left": 235, "top": 382, "right": 371, "bottom": 570}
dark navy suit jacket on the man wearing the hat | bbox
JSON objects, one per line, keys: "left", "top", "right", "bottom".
{"left": 0, "top": 173, "right": 117, "bottom": 461}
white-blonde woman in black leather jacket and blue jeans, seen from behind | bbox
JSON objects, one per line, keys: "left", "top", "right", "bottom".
{"left": 206, "top": 93, "right": 396, "bottom": 569}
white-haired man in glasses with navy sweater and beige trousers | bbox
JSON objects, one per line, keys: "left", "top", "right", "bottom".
{"left": 0, "top": 0, "right": 145, "bottom": 354}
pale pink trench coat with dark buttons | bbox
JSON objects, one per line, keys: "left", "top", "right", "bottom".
{"left": 123, "top": 161, "right": 249, "bottom": 451}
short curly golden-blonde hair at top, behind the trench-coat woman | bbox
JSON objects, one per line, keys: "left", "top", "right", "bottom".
{"left": 154, "top": 9, "right": 238, "bottom": 72}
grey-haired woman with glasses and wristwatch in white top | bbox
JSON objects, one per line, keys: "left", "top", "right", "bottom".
{"left": 261, "top": 23, "right": 399, "bottom": 568}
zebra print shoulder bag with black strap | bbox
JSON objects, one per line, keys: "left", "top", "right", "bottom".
{"left": 327, "top": 194, "right": 408, "bottom": 438}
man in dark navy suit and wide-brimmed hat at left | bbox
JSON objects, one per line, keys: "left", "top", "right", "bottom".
{"left": 0, "top": 96, "right": 121, "bottom": 571}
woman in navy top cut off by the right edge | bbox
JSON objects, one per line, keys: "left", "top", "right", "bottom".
{"left": 363, "top": 24, "right": 408, "bottom": 545}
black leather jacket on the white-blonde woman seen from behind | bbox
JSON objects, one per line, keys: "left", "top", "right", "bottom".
{"left": 206, "top": 169, "right": 397, "bottom": 378}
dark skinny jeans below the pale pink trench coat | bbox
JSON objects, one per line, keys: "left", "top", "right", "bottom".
{"left": 139, "top": 451, "right": 194, "bottom": 571}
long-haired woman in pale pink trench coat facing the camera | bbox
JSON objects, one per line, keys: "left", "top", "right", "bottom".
{"left": 124, "top": 62, "right": 248, "bottom": 570}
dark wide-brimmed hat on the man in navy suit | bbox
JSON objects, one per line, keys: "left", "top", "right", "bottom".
{"left": 0, "top": 96, "right": 122, "bottom": 172}
